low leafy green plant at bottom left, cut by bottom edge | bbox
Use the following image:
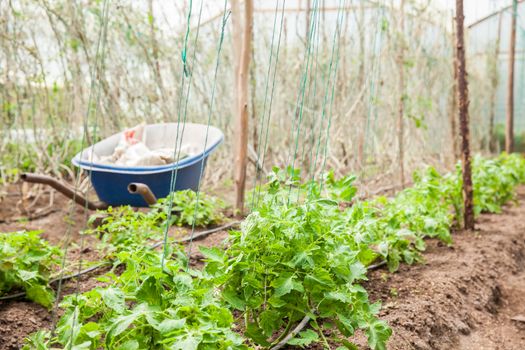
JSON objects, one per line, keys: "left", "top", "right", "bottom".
{"left": 24, "top": 250, "right": 248, "bottom": 350}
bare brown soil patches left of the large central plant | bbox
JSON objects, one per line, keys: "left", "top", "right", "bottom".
{"left": 0, "top": 184, "right": 227, "bottom": 350}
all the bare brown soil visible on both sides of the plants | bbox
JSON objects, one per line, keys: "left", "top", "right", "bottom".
{"left": 0, "top": 188, "right": 525, "bottom": 350}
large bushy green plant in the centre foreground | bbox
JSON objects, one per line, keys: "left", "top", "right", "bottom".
{"left": 201, "top": 171, "right": 391, "bottom": 349}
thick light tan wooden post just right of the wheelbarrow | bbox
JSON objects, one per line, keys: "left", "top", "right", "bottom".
{"left": 235, "top": 0, "right": 253, "bottom": 214}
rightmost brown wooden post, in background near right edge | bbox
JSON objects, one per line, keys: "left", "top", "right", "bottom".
{"left": 505, "top": 0, "right": 518, "bottom": 153}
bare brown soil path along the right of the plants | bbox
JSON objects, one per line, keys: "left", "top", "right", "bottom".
{"left": 356, "top": 187, "right": 525, "bottom": 350}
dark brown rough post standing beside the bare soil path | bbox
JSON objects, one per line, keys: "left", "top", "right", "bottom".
{"left": 456, "top": 0, "right": 474, "bottom": 230}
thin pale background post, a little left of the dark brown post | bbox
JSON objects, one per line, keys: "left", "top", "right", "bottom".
{"left": 397, "top": 0, "right": 406, "bottom": 188}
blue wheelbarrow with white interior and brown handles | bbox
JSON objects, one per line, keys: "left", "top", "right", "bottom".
{"left": 22, "top": 123, "right": 224, "bottom": 210}
